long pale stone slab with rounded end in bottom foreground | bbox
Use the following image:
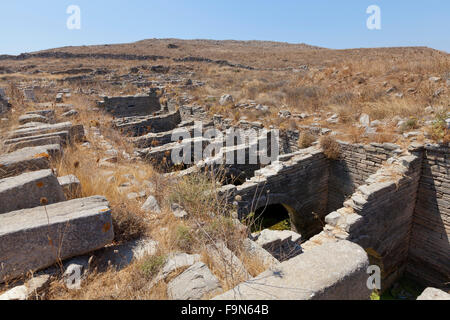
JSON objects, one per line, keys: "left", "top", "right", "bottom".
{"left": 214, "top": 241, "right": 371, "bottom": 300}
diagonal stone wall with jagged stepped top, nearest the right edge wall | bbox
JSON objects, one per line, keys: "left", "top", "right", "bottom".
{"left": 324, "top": 155, "right": 421, "bottom": 290}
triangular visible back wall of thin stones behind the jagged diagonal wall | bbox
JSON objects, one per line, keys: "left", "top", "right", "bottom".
{"left": 328, "top": 141, "right": 400, "bottom": 212}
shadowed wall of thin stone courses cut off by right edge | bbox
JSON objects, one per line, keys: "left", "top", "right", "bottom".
{"left": 407, "top": 145, "right": 450, "bottom": 290}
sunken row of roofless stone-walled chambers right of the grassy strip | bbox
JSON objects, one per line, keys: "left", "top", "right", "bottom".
{"left": 95, "top": 92, "right": 450, "bottom": 299}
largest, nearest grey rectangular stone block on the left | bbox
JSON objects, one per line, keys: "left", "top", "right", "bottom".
{"left": 0, "top": 196, "right": 114, "bottom": 282}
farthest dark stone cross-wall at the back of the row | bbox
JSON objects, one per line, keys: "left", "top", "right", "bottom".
{"left": 99, "top": 93, "right": 161, "bottom": 118}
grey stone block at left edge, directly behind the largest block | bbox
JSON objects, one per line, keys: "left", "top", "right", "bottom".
{"left": 0, "top": 169, "right": 66, "bottom": 214}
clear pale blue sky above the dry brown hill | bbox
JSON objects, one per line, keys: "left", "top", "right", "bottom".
{"left": 0, "top": 0, "right": 450, "bottom": 54}
